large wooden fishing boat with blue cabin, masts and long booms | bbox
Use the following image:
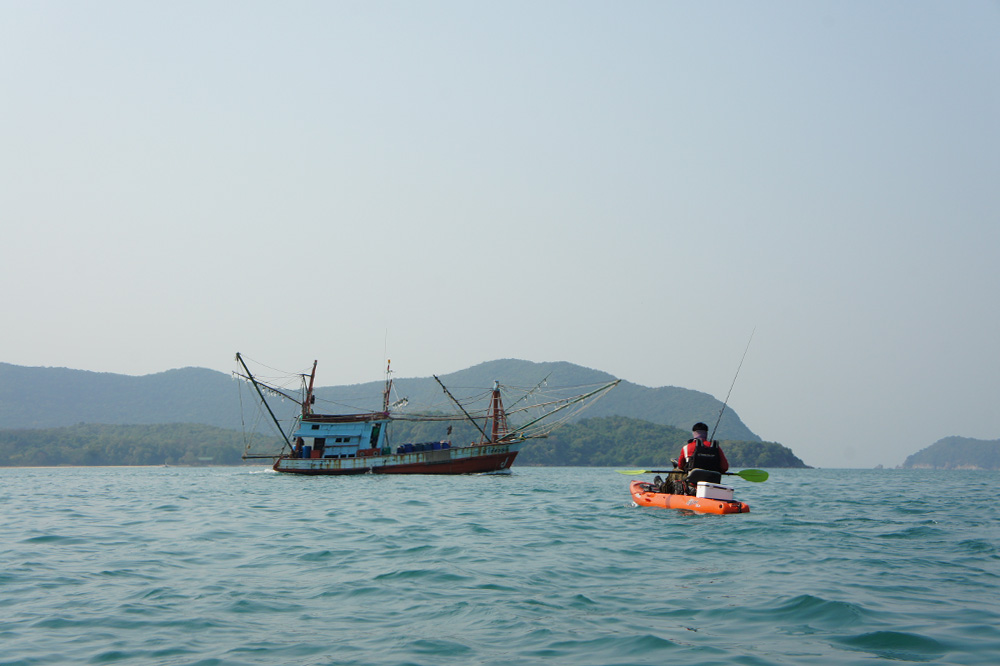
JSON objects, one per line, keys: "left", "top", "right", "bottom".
{"left": 234, "top": 353, "right": 620, "bottom": 475}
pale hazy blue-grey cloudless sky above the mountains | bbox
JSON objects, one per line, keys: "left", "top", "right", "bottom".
{"left": 0, "top": 0, "right": 1000, "bottom": 467}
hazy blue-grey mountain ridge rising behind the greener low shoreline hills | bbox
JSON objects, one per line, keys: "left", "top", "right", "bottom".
{"left": 0, "top": 359, "right": 760, "bottom": 441}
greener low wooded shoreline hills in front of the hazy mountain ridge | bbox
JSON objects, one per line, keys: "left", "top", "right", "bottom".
{"left": 0, "top": 416, "right": 806, "bottom": 468}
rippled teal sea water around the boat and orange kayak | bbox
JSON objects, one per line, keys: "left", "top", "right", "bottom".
{"left": 0, "top": 465, "right": 1000, "bottom": 666}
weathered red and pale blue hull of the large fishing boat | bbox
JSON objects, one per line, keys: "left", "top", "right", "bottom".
{"left": 274, "top": 442, "right": 522, "bottom": 476}
